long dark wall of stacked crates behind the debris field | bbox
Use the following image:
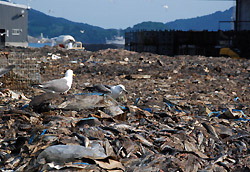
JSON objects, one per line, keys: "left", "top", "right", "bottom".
{"left": 125, "top": 30, "right": 250, "bottom": 58}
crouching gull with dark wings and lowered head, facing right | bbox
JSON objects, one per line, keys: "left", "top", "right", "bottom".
{"left": 85, "top": 84, "right": 127, "bottom": 99}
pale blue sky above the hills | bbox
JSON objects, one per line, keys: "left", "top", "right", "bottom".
{"left": 11, "top": 0, "right": 235, "bottom": 29}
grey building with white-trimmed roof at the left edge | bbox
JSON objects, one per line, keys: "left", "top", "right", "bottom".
{"left": 0, "top": 1, "right": 29, "bottom": 47}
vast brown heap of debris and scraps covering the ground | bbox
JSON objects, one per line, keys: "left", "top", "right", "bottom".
{"left": 0, "top": 47, "right": 250, "bottom": 172}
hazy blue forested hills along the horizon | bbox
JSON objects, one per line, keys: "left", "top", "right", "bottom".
{"left": 28, "top": 7, "right": 233, "bottom": 44}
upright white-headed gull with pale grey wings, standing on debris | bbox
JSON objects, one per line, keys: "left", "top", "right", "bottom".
{"left": 35, "top": 69, "right": 73, "bottom": 93}
